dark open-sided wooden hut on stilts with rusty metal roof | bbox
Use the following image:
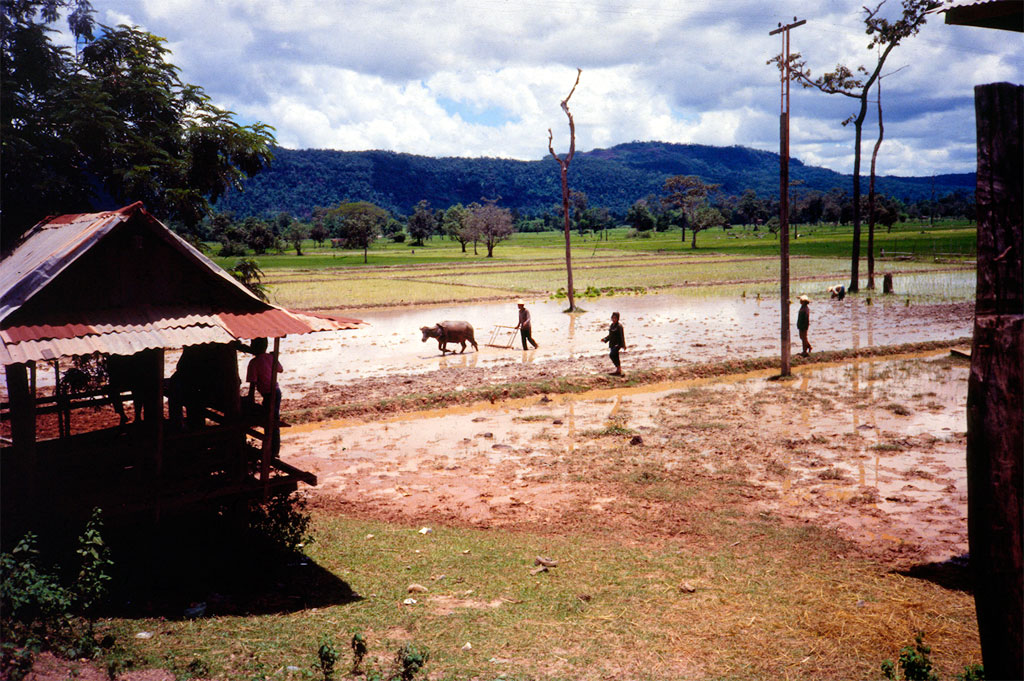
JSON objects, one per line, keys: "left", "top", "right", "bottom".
{"left": 0, "top": 203, "right": 362, "bottom": 528}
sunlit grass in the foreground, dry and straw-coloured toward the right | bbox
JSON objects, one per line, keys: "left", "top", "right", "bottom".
{"left": 99, "top": 512, "right": 974, "bottom": 681}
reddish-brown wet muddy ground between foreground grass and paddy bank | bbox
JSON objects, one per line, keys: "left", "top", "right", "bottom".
{"left": 283, "top": 352, "right": 968, "bottom": 567}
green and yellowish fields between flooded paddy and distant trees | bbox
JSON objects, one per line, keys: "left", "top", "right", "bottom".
{"left": 205, "top": 224, "right": 976, "bottom": 310}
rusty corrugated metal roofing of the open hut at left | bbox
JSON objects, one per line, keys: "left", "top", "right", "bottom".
{"left": 0, "top": 204, "right": 364, "bottom": 365}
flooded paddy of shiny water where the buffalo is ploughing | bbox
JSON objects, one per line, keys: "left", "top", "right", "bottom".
{"left": 282, "top": 293, "right": 973, "bottom": 397}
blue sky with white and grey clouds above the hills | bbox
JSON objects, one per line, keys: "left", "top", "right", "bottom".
{"left": 77, "top": 0, "right": 1024, "bottom": 175}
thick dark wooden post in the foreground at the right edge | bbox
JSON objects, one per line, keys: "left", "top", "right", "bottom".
{"left": 967, "top": 83, "right": 1024, "bottom": 679}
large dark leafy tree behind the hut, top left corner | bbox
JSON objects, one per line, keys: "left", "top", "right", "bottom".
{"left": 0, "top": 0, "right": 274, "bottom": 249}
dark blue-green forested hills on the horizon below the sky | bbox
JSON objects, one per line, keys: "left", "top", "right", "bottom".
{"left": 217, "top": 142, "right": 975, "bottom": 217}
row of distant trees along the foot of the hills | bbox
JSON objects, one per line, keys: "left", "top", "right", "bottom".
{"left": 199, "top": 175, "right": 974, "bottom": 261}
